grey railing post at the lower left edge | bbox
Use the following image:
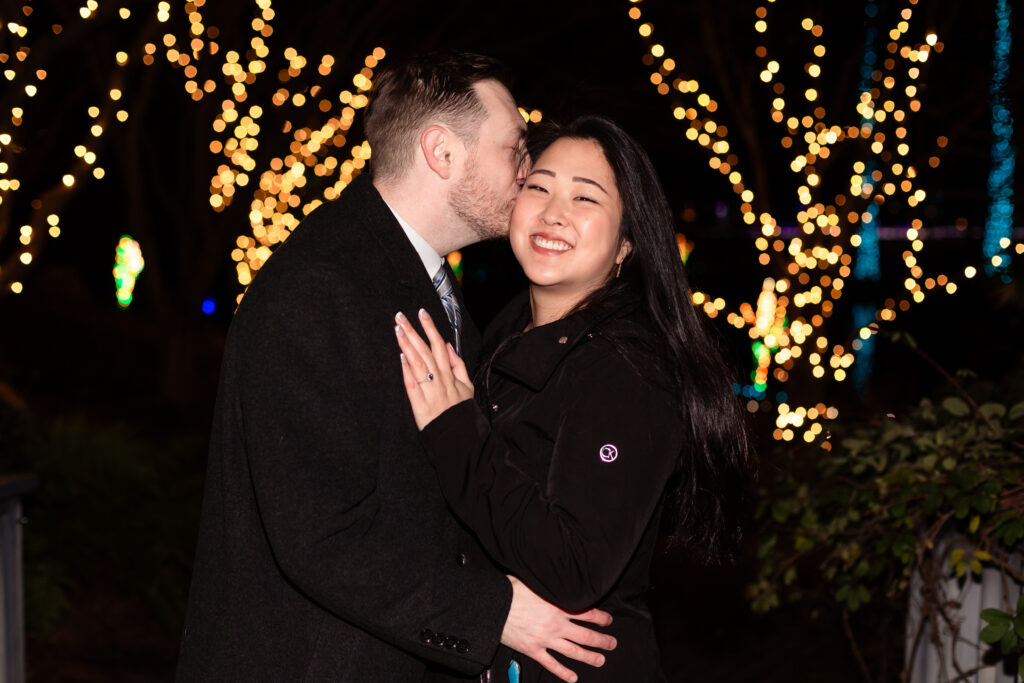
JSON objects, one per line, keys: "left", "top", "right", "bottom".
{"left": 0, "top": 475, "right": 36, "bottom": 683}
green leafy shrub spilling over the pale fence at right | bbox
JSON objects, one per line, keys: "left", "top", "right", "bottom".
{"left": 748, "top": 394, "right": 1024, "bottom": 675}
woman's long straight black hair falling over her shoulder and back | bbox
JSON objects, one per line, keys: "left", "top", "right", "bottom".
{"left": 527, "top": 115, "right": 754, "bottom": 560}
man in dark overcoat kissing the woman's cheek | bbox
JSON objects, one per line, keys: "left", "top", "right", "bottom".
{"left": 178, "top": 54, "right": 614, "bottom": 683}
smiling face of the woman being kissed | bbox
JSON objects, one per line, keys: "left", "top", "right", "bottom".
{"left": 509, "top": 137, "right": 630, "bottom": 301}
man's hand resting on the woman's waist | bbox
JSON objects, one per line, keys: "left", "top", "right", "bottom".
{"left": 502, "top": 577, "right": 615, "bottom": 683}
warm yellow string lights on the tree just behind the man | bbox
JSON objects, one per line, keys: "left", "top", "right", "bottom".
{"left": 137, "top": 0, "right": 385, "bottom": 290}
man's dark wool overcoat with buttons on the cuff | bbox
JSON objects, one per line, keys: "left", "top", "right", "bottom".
{"left": 177, "top": 177, "right": 512, "bottom": 683}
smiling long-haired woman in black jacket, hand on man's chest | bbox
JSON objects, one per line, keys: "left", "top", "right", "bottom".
{"left": 395, "top": 117, "right": 751, "bottom": 682}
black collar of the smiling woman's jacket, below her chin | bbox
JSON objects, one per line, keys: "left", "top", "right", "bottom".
{"left": 490, "top": 295, "right": 640, "bottom": 391}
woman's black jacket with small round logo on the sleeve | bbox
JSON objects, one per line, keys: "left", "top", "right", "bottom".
{"left": 421, "top": 296, "right": 686, "bottom": 683}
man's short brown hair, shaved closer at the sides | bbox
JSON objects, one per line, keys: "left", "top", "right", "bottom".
{"left": 364, "top": 52, "right": 511, "bottom": 178}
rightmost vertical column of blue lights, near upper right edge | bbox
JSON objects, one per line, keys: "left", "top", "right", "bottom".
{"left": 982, "top": 0, "right": 1017, "bottom": 282}
